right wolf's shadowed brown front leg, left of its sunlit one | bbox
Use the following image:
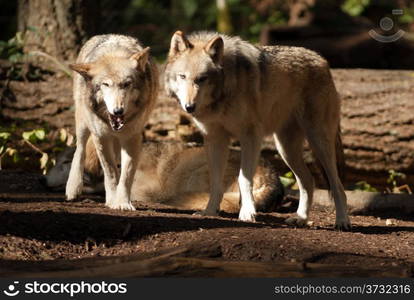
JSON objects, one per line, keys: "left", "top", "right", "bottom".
{"left": 200, "top": 130, "right": 230, "bottom": 216}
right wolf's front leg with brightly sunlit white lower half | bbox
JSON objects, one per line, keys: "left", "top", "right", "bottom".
{"left": 238, "top": 134, "right": 262, "bottom": 221}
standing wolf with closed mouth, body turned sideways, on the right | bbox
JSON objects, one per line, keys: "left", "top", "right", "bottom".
{"left": 164, "top": 31, "right": 350, "bottom": 229}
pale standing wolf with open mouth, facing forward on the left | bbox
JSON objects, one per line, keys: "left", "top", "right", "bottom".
{"left": 66, "top": 34, "right": 158, "bottom": 210}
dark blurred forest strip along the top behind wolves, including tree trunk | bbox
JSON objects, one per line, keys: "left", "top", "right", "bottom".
{"left": 0, "top": 0, "right": 414, "bottom": 66}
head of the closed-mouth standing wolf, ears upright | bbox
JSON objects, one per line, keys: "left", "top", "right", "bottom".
{"left": 165, "top": 31, "right": 224, "bottom": 116}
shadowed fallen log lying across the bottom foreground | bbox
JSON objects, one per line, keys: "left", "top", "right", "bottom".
{"left": 0, "top": 244, "right": 411, "bottom": 278}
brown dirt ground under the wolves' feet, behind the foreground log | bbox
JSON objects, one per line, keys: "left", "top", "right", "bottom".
{"left": 0, "top": 171, "right": 414, "bottom": 277}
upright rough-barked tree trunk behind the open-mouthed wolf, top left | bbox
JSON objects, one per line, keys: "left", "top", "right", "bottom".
{"left": 18, "top": 0, "right": 99, "bottom": 61}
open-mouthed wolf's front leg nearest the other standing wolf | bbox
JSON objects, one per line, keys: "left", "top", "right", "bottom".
{"left": 110, "top": 134, "right": 142, "bottom": 210}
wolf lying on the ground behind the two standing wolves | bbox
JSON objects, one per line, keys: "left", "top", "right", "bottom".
{"left": 44, "top": 139, "right": 284, "bottom": 213}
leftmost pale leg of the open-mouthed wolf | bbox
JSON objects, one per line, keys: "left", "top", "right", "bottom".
{"left": 66, "top": 124, "right": 90, "bottom": 200}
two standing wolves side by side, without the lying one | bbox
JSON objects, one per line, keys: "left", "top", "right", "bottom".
{"left": 66, "top": 31, "right": 350, "bottom": 229}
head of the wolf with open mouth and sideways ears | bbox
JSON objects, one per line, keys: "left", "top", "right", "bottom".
{"left": 70, "top": 47, "right": 149, "bottom": 131}
